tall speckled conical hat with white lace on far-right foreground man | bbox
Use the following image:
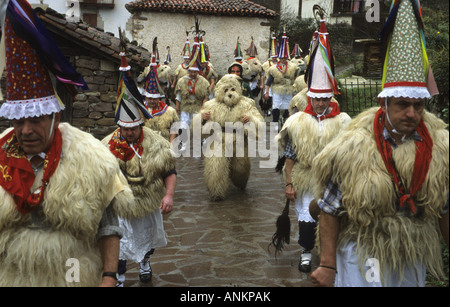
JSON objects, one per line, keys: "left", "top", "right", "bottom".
{"left": 378, "top": 0, "right": 437, "bottom": 98}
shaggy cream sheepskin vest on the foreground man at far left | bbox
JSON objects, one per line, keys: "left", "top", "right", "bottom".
{"left": 0, "top": 123, "right": 132, "bottom": 287}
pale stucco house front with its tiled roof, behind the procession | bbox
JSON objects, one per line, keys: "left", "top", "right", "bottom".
{"left": 125, "top": 0, "right": 277, "bottom": 76}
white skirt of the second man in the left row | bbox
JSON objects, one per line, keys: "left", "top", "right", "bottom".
{"left": 119, "top": 209, "right": 167, "bottom": 262}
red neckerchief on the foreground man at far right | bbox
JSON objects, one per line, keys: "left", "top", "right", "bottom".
{"left": 374, "top": 108, "right": 433, "bottom": 214}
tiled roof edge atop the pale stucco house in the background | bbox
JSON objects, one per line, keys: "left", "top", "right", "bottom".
{"left": 125, "top": 0, "right": 277, "bottom": 18}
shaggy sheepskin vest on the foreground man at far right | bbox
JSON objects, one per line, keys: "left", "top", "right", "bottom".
{"left": 313, "top": 108, "right": 449, "bottom": 280}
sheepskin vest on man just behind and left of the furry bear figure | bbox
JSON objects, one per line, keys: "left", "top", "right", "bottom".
{"left": 175, "top": 75, "right": 209, "bottom": 113}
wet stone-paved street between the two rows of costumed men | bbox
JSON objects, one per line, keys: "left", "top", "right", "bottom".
{"left": 124, "top": 119, "right": 318, "bottom": 287}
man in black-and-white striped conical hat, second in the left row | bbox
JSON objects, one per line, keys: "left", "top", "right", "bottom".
{"left": 102, "top": 52, "right": 176, "bottom": 286}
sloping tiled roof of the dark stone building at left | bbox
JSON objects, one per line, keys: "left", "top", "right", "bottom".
{"left": 35, "top": 8, "right": 151, "bottom": 70}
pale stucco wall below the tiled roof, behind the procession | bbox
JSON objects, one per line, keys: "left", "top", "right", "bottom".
{"left": 128, "top": 12, "right": 270, "bottom": 75}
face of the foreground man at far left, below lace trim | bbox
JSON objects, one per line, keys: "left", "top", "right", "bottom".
{"left": 12, "top": 113, "right": 61, "bottom": 155}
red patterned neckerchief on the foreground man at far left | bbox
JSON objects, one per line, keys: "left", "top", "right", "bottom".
{"left": 0, "top": 129, "right": 62, "bottom": 214}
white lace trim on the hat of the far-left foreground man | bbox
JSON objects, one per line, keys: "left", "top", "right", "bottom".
{"left": 0, "top": 95, "right": 64, "bottom": 120}
